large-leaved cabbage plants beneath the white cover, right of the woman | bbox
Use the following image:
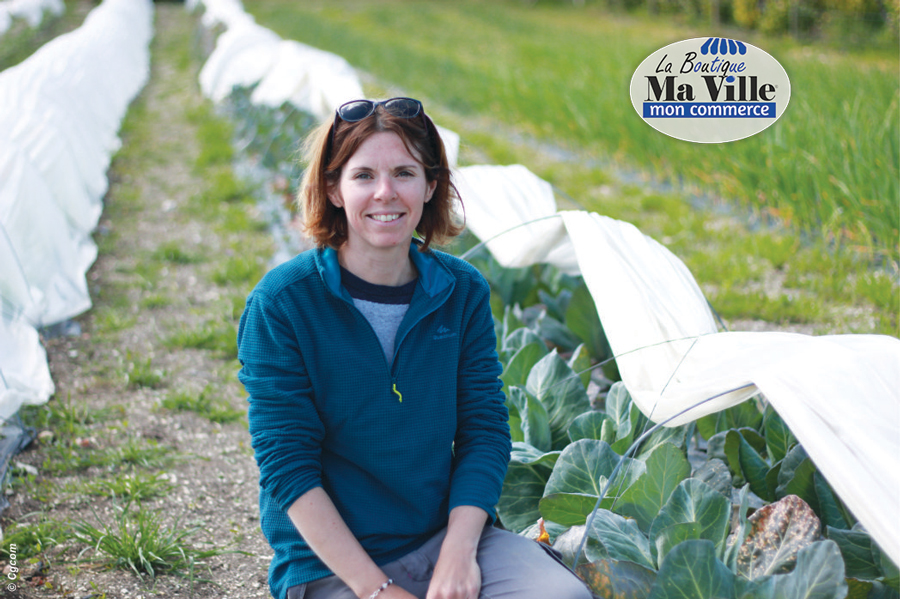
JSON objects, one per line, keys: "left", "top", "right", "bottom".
{"left": 481, "top": 251, "right": 898, "bottom": 599}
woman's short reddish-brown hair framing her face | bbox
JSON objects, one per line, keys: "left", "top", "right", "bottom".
{"left": 297, "top": 106, "right": 463, "bottom": 251}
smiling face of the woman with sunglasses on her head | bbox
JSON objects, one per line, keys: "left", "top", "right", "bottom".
{"left": 328, "top": 132, "right": 437, "bottom": 256}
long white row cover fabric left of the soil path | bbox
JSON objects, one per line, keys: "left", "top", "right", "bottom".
{"left": 0, "top": 0, "right": 153, "bottom": 416}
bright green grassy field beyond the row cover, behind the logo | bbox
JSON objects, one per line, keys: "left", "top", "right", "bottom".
{"left": 248, "top": 0, "right": 900, "bottom": 335}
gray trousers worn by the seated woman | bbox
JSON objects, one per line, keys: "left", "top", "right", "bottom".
{"left": 287, "top": 526, "right": 593, "bottom": 599}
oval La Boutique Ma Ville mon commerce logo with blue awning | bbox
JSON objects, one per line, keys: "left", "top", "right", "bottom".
{"left": 631, "top": 37, "right": 791, "bottom": 143}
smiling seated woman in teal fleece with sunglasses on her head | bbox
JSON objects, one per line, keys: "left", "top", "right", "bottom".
{"left": 238, "top": 98, "right": 590, "bottom": 599}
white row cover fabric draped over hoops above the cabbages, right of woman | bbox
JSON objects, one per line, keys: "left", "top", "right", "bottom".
{"left": 458, "top": 166, "right": 900, "bottom": 563}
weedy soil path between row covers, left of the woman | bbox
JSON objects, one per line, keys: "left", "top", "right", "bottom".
{"left": 0, "top": 3, "right": 271, "bottom": 599}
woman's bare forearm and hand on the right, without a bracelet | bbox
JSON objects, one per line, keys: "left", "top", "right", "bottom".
{"left": 426, "top": 505, "right": 487, "bottom": 599}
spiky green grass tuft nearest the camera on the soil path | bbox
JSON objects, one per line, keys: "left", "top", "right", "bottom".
{"left": 72, "top": 503, "right": 224, "bottom": 579}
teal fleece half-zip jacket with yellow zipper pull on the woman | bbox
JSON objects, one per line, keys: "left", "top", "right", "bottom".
{"left": 238, "top": 243, "right": 510, "bottom": 598}
